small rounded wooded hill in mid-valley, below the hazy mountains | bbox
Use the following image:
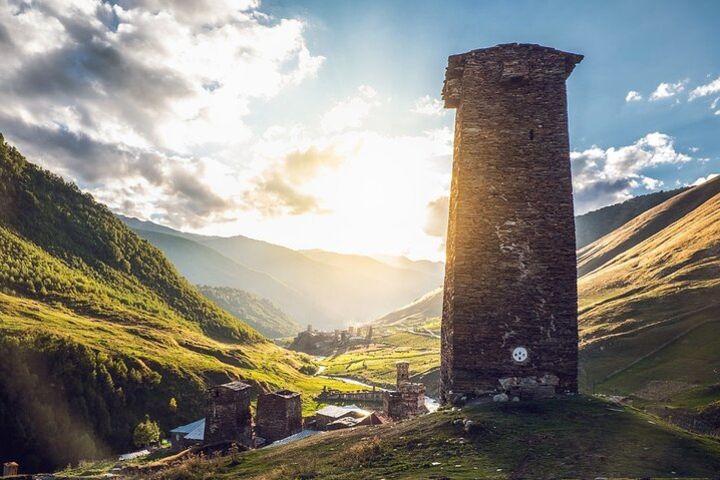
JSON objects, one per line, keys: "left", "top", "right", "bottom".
{"left": 198, "top": 285, "right": 302, "bottom": 338}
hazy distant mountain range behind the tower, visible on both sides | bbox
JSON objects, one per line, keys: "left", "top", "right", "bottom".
{"left": 119, "top": 189, "right": 668, "bottom": 335}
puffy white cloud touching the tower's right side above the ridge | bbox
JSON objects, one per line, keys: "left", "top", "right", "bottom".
{"left": 570, "top": 132, "right": 692, "bottom": 214}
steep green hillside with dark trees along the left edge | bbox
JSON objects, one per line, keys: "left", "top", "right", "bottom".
{"left": 0, "top": 138, "right": 352, "bottom": 471}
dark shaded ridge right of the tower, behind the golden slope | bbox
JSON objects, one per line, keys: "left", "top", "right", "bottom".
{"left": 575, "top": 187, "right": 687, "bottom": 249}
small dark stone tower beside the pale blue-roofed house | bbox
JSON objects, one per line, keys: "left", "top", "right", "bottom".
{"left": 205, "top": 381, "right": 253, "bottom": 448}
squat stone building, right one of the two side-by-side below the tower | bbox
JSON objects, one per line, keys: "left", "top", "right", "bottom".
{"left": 255, "top": 390, "right": 302, "bottom": 442}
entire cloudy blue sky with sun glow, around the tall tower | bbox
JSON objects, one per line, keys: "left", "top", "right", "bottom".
{"left": 0, "top": 0, "right": 720, "bottom": 260}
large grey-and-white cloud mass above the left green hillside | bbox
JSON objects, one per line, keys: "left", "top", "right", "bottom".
{"left": 0, "top": 0, "right": 324, "bottom": 227}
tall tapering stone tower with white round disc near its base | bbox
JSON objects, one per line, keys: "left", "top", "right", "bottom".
{"left": 441, "top": 44, "right": 583, "bottom": 402}
